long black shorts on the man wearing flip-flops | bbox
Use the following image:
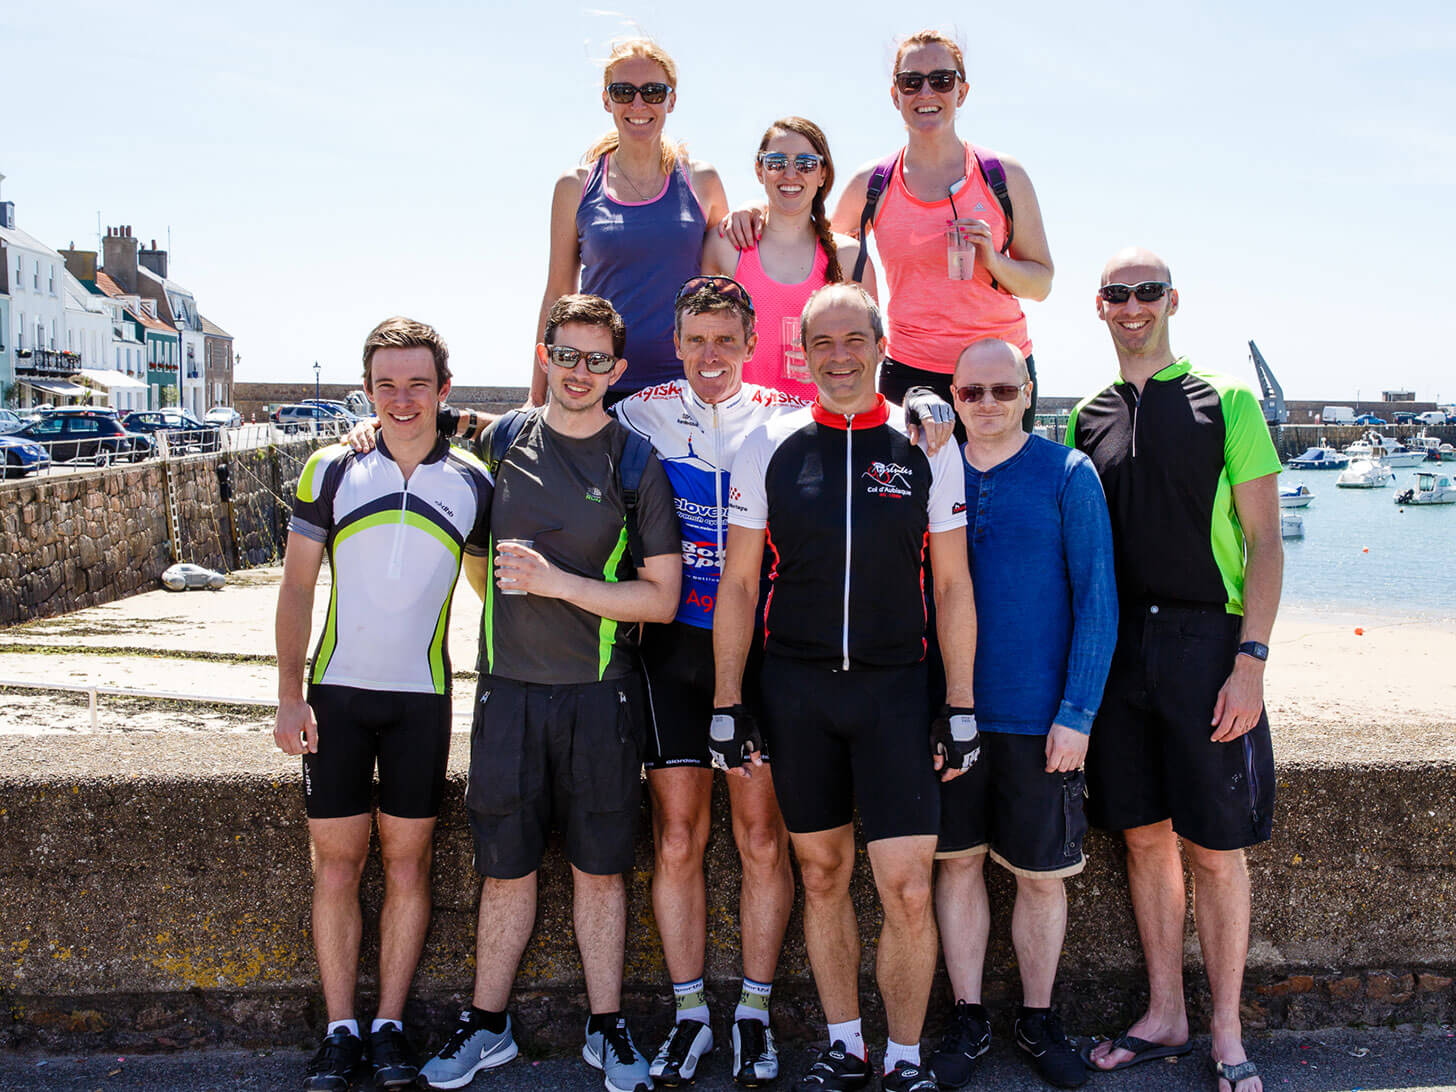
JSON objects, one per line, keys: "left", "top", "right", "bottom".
{"left": 1088, "top": 603, "right": 1274, "bottom": 849}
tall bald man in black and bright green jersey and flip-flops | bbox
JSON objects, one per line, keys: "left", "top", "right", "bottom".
{"left": 1067, "top": 249, "right": 1283, "bottom": 1092}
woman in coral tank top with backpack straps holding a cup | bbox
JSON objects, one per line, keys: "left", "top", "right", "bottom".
{"left": 833, "top": 31, "right": 1053, "bottom": 431}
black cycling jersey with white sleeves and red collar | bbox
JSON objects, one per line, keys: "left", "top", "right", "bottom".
{"left": 728, "top": 397, "right": 965, "bottom": 671}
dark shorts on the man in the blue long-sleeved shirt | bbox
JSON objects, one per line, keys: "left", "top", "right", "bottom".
{"left": 935, "top": 731, "right": 1088, "bottom": 879}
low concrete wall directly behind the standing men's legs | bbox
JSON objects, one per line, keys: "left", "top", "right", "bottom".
{"left": 0, "top": 724, "right": 1456, "bottom": 1051}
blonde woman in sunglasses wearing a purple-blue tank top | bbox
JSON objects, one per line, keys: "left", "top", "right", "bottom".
{"left": 529, "top": 38, "right": 728, "bottom": 405}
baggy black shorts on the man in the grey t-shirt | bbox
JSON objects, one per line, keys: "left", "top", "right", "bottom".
{"left": 464, "top": 676, "right": 646, "bottom": 879}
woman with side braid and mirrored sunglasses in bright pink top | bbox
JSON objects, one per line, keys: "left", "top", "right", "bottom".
{"left": 703, "top": 118, "right": 867, "bottom": 402}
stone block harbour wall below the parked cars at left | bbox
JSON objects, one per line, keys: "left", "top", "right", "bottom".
{"left": 0, "top": 438, "right": 320, "bottom": 625}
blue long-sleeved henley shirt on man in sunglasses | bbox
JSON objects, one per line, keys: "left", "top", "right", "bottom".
{"left": 961, "top": 435, "right": 1117, "bottom": 735}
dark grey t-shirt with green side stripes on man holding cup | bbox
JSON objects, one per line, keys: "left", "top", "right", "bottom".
{"left": 476, "top": 414, "right": 683, "bottom": 683}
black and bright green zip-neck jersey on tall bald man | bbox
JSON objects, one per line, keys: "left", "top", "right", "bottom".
{"left": 1067, "top": 357, "right": 1280, "bottom": 614}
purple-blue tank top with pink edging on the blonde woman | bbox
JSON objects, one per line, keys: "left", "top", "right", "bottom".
{"left": 577, "top": 156, "right": 708, "bottom": 392}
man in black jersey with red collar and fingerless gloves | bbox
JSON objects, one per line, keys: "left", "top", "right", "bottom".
{"left": 712, "top": 284, "right": 978, "bottom": 1092}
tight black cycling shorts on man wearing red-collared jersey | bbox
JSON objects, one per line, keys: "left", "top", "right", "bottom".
{"left": 761, "top": 652, "right": 941, "bottom": 842}
